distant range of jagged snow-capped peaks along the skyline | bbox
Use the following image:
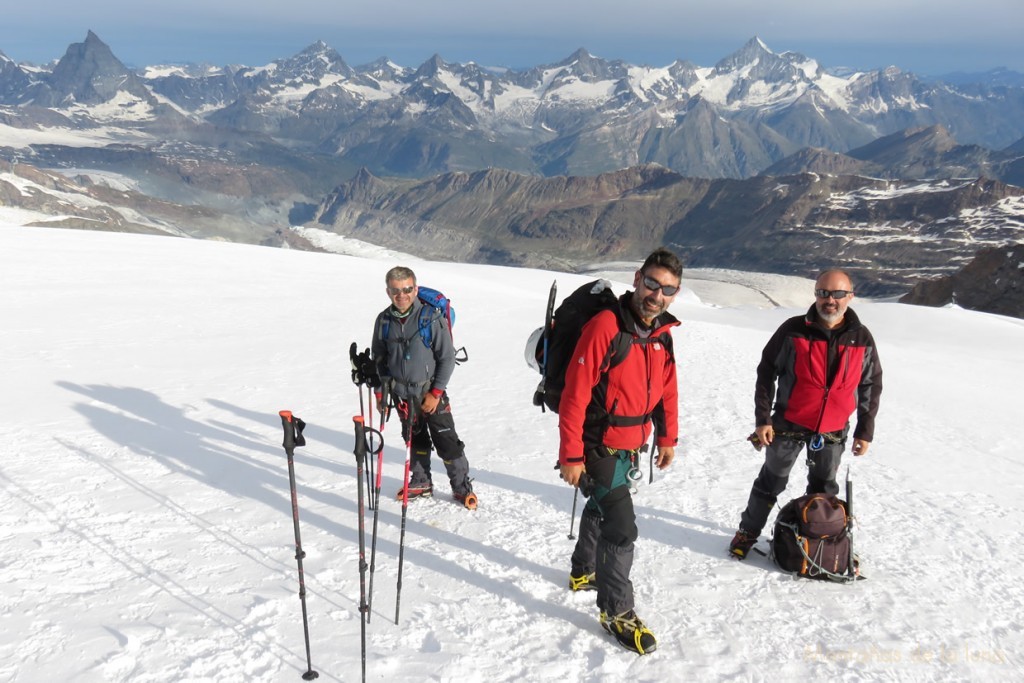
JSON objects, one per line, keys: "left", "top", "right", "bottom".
{"left": 0, "top": 32, "right": 1024, "bottom": 177}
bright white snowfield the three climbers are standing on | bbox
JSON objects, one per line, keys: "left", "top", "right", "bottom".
{"left": 0, "top": 227, "right": 1024, "bottom": 683}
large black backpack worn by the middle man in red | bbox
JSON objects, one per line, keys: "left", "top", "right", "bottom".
{"left": 526, "top": 280, "right": 672, "bottom": 413}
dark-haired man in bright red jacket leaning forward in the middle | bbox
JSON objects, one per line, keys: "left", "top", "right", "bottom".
{"left": 558, "top": 249, "right": 683, "bottom": 654}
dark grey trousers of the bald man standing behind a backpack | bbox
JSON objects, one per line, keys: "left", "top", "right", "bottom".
{"left": 739, "top": 431, "right": 846, "bottom": 537}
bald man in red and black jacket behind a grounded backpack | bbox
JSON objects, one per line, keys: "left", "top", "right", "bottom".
{"left": 729, "top": 270, "right": 882, "bottom": 559}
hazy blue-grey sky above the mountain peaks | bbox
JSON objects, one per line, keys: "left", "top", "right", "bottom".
{"left": 0, "top": 0, "right": 1024, "bottom": 75}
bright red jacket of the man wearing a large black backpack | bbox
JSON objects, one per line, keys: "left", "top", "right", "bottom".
{"left": 558, "top": 292, "right": 679, "bottom": 465}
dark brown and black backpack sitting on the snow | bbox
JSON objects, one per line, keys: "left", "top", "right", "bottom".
{"left": 771, "top": 494, "right": 859, "bottom": 582}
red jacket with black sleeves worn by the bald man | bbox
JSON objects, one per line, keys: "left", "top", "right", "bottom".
{"left": 754, "top": 305, "right": 882, "bottom": 441}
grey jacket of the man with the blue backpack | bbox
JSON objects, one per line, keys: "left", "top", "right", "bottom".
{"left": 371, "top": 299, "right": 455, "bottom": 400}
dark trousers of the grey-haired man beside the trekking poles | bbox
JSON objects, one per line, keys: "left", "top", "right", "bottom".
{"left": 401, "top": 393, "right": 473, "bottom": 496}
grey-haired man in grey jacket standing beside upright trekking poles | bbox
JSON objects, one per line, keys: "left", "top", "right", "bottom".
{"left": 371, "top": 266, "right": 477, "bottom": 510}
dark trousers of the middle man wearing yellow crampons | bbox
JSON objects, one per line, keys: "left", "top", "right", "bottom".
{"left": 572, "top": 447, "right": 637, "bottom": 615}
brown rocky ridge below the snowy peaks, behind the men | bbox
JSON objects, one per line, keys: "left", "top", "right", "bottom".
{"left": 310, "top": 166, "right": 1024, "bottom": 295}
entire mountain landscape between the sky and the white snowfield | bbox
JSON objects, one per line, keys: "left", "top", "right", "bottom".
{"left": 0, "top": 32, "right": 1024, "bottom": 305}
